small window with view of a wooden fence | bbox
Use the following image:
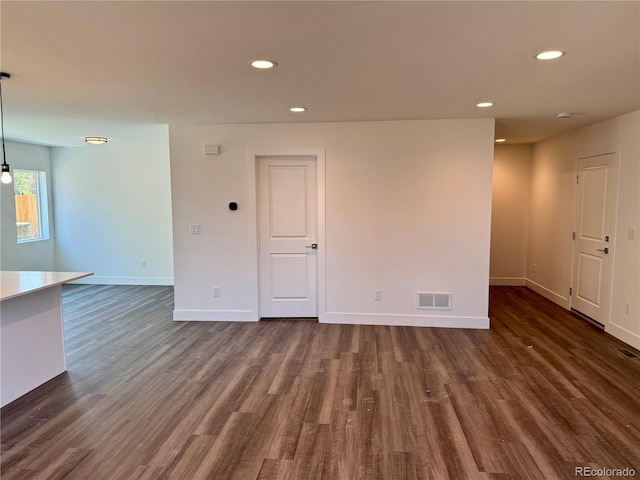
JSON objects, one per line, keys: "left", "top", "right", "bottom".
{"left": 13, "top": 170, "right": 49, "bottom": 243}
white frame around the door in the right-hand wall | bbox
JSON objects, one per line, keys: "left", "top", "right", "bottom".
{"left": 569, "top": 146, "right": 620, "bottom": 330}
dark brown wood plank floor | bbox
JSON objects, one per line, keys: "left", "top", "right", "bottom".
{"left": 1, "top": 285, "right": 640, "bottom": 480}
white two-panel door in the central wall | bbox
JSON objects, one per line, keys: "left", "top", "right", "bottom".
{"left": 257, "top": 157, "right": 318, "bottom": 318}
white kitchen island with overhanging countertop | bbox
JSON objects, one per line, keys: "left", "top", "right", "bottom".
{"left": 0, "top": 271, "right": 92, "bottom": 406}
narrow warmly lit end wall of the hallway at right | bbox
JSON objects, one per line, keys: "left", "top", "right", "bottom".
{"left": 490, "top": 144, "right": 532, "bottom": 285}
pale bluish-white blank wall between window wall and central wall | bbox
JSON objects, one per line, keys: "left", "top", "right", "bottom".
{"left": 52, "top": 144, "right": 173, "bottom": 285}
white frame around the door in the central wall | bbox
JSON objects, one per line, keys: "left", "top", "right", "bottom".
{"left": 247, "top": 148, "right": 326, "bottom": 321}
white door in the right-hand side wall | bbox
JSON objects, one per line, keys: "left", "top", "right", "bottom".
{"left": 571, "top": 153, "right": 617, "bottom": 325}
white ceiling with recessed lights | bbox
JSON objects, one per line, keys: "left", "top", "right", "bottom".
{"left": 0, "top": 0, "right": 640, "bottom": 145}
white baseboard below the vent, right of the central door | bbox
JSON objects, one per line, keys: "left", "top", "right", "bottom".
{"left": 320, "top": 312, "right": 490, "bottom": 330}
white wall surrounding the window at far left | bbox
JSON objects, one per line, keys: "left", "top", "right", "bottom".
{"left": 0, "top": 141, "right": 56, "bottom": 271}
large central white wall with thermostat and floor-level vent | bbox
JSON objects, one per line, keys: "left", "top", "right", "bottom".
{"left": 169, "top": 119, "right": 494, "bottom": 328}
